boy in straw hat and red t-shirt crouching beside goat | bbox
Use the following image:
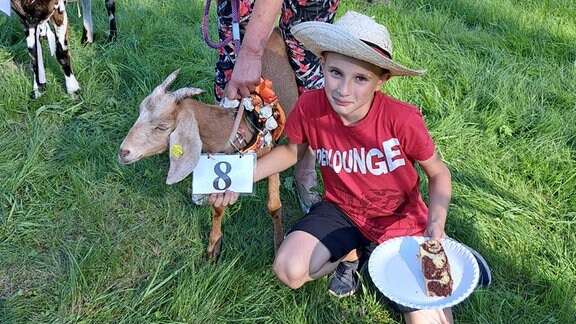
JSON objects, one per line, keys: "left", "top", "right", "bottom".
{"left": 209, "top": 12, "right": 490, "bottom": 323}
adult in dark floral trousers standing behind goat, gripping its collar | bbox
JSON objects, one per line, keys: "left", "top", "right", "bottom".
{"left": 215, "top": 0, "right": 340, "bottom": 211}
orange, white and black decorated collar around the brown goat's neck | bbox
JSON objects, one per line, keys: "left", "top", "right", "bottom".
{"left": 221, "top": 78, "right": 286, "bottom": 153}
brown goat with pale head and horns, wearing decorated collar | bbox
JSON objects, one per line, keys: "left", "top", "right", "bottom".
{"left": 118, "top": 32, "right": 298, "bottom": 258}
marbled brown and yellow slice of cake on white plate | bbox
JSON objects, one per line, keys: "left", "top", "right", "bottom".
{"left": 418, "top": 239, "right": 454, "bottom": 297}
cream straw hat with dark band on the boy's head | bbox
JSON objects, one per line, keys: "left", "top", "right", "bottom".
{"left": 291, "top": 11, "right": 426, "bottom": 76}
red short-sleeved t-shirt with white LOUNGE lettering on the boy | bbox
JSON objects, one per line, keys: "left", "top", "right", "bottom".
{"left": 285, "top": 89, "right": 435, "bottom": 243}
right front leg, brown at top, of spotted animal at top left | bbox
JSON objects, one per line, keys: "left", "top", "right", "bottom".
{"left": 50, "top": 8, "right": 80, "bottom": 97}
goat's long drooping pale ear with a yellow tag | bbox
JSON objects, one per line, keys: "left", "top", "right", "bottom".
{"left": 166, "top": 111, "right": 202, "bottom": 185}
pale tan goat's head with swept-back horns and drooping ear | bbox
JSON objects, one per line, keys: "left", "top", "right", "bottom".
{"left": 118, "top": 70, "right": 204, "bottom": 184}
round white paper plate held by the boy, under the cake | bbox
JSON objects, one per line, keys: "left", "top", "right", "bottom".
{"left": 368, "top": 236, "right": 480, "bottom": 309}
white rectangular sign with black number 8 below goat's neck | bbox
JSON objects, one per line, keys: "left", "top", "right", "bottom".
{"left": 192, "top": 154, "right": 256, "bottom": 194}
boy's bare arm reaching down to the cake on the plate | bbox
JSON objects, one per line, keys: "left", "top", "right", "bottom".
{"left": 418, "top": 153, "right": 452, "bottom": 240}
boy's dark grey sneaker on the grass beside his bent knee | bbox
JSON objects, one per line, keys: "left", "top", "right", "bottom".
{"left": 328, "top": 260, "right": 361, "bottom": 298}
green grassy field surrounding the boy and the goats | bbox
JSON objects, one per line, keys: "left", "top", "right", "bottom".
{"left": 0, "top": 0, "right": 576, "bottom": 323}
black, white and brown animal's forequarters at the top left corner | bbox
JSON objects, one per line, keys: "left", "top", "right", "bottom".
{"left": 10, "top": 0, "right": 80, "bottom": 98}
